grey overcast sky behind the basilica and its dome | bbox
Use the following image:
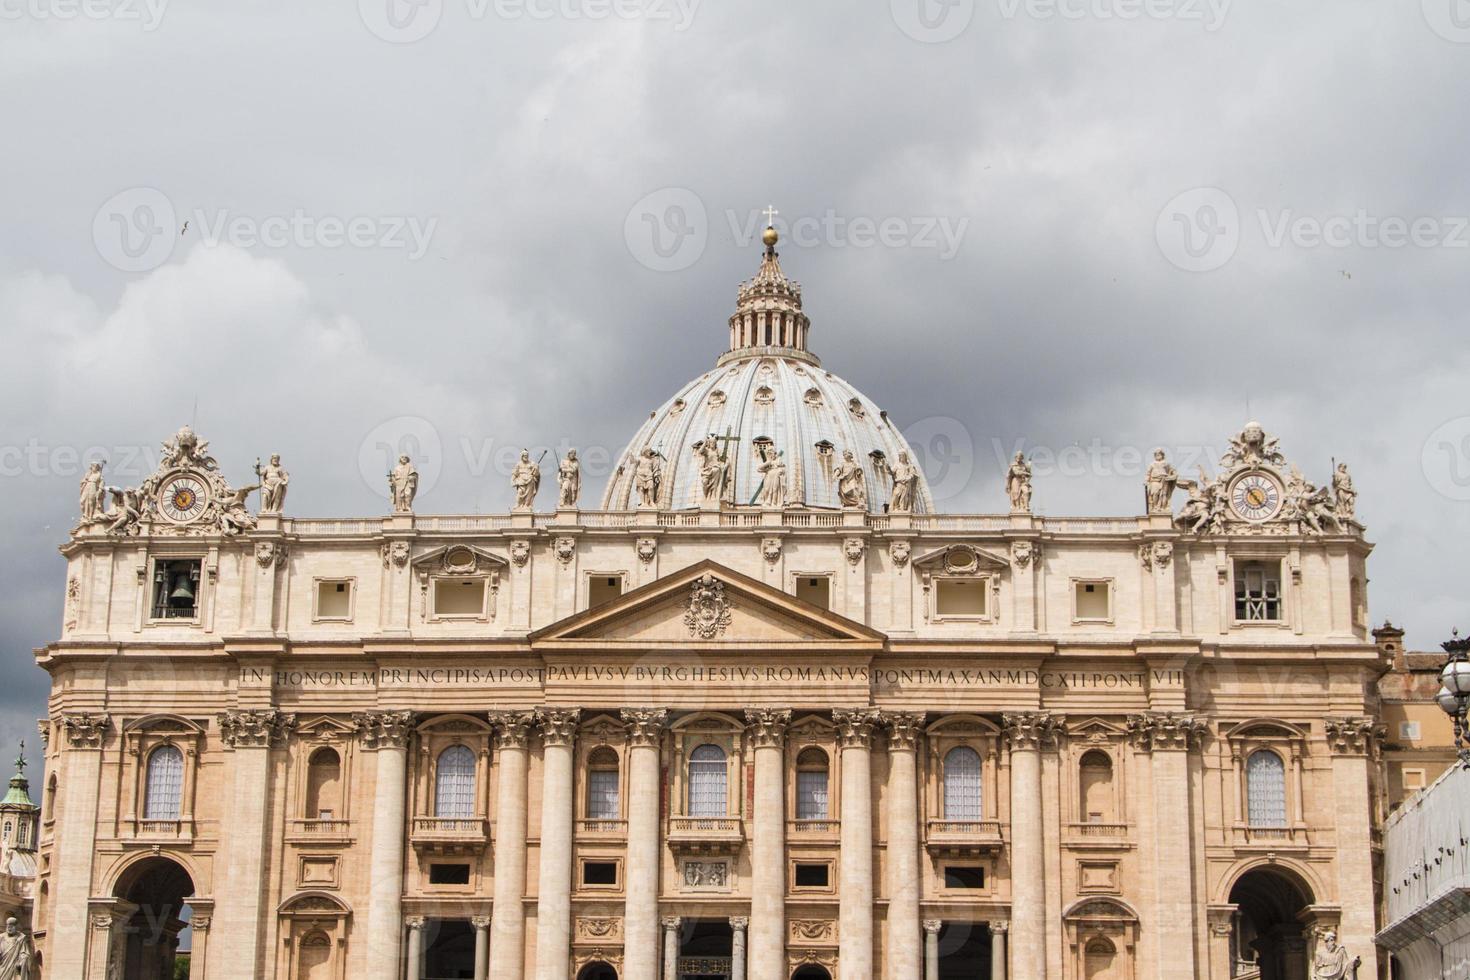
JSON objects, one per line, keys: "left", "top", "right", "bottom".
{"left": 0, "top": 0, "right": 1470, "bottom": 775}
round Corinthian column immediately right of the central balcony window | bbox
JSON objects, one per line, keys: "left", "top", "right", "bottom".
{"left": 745, "top": 708, "right": 791, "bottom": 980}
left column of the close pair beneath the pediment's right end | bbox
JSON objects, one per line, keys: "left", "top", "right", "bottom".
{"left": 832, "top": 708, "right": 879, "bottom": 980}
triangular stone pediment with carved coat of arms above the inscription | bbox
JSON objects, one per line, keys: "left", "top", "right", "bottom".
{"left": 531, "top": 561, "right": 883, "bottom": 649}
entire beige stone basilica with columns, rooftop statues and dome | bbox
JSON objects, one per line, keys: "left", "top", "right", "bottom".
{"left": 31, "top": 229, "right": 1391, "bottom": 980}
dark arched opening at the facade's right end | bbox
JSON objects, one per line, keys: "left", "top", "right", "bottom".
{"left": 1230, "top": 868, "right": 1313, "bottom": 980}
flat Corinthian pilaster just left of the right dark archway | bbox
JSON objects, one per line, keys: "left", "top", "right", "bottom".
{"left": 1123, "top": 711, "right": 1207, "bottom": 980}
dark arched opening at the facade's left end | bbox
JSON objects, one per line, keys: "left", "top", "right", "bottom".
{"left": 112, "top": 857, "right": 194, "bottom": 980}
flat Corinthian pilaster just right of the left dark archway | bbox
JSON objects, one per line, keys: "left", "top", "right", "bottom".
{"left": 215, "top": 710, "right": 294, "bottom": 977}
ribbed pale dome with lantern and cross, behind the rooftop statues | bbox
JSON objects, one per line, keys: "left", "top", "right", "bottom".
{"left": 603, "top": 229, "right": 933, "bottom": 514}
